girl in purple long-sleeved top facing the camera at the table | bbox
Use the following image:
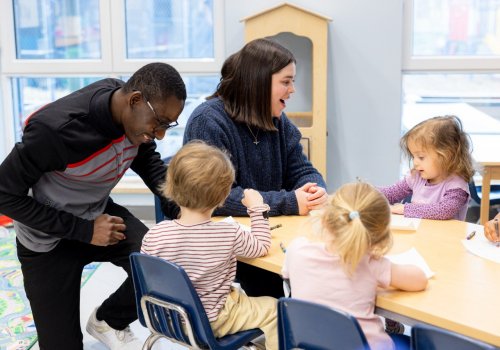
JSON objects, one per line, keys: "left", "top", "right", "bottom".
{"left": 379, "top": 116, "right": 474, "bottom": 220}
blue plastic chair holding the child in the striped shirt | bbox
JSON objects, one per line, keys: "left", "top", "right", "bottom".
{"left": 130, "top": 253, "right": 262, "bottom": 350}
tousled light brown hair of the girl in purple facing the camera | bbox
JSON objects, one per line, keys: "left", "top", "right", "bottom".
{"left": 400, "top": 115, "right": 474, "bottom": 182}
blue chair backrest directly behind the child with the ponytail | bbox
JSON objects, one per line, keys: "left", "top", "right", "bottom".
{"left": 278, "top": 298, "right": 369, "bottom": 350}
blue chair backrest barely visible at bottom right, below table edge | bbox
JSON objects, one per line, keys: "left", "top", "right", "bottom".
{"left": 411, "top": 324, "right": 497, "bottom": 350}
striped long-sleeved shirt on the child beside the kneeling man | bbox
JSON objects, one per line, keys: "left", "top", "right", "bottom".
{"left": 141, "top": 204, "right": 271, "bottom": 322}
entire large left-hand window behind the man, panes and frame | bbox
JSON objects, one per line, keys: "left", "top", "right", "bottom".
{"left": 0, "top": 0, "right": 224, "bottom": 158}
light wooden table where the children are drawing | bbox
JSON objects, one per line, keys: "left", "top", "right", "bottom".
{"left": 232, "top": 216, "right": 500, "bottom": 346}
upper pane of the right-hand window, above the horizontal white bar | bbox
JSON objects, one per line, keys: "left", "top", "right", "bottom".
{"left": 403, "top": 0, "right": 500, "bottom": 71}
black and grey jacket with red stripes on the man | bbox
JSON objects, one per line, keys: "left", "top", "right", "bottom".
{"left": 0, "top": 79, "right": 178, "bottom": 251}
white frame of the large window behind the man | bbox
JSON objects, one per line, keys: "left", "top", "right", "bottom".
{"left": 0, "top": 0, "right": 225, "bottom": 159}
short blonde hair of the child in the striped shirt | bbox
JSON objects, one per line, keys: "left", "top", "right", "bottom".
{"left": 162, "top": 140, "right": 234, "bottom": 210}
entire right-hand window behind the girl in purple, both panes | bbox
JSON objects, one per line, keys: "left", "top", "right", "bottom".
{"left": 402, "top": 0, "right": 500, "bottom": 174}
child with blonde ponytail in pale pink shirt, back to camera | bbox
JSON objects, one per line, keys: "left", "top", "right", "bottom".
{"left": 282, "top": 183, "right": 427, "bottom": 350}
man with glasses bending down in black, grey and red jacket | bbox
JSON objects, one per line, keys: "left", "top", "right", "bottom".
{"left": 0, "top": 63, "right": 186, "bottom": 350}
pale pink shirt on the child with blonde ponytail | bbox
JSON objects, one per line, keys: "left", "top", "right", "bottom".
{"left": 282, "top": 237, "right": 394, "bottom": 350}
